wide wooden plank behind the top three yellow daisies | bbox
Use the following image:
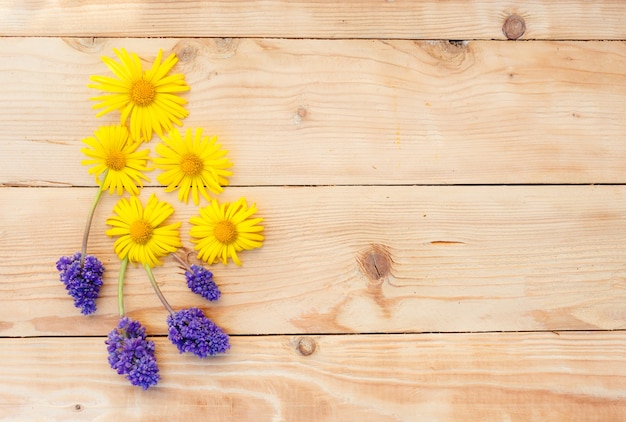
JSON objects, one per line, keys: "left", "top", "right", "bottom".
{"left": 0, "top": 38, "right": 626, "bottom": 186}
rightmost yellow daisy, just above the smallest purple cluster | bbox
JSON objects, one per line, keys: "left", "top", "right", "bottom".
{"left": 189, "top": 198, "right": 264, "bottom": 265}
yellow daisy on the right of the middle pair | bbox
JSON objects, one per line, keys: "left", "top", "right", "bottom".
{"left": 154, "top": 128, "right": 233, "bottom": 205}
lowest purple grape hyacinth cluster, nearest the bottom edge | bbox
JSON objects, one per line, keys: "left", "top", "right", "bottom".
{"left": 104, "top": 317, "right": 160, "bottom": 390}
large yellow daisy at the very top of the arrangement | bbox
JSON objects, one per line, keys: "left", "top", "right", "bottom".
{"left": 88, "top": 49, "right": 189, "bottom": 142}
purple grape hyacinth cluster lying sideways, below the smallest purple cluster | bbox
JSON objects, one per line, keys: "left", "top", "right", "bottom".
{"left": 167, "top": 308, "right": 230, "bottom": 358}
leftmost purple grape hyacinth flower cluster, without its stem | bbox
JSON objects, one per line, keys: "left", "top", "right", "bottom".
{"left": 57, "top": 252, "right": 104, "bottom": 315}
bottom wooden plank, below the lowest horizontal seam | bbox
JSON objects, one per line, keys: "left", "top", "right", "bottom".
{"left": 0, "top": 332, "right": 626, "bottom": 422}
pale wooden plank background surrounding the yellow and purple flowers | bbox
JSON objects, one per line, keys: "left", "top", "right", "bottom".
{"left": 0, "top": 0, "right": 626, "bottom": 421}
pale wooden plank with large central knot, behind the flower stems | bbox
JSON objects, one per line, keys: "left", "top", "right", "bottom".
{"left": 0, "top": 186, "right": 626, "bottom": 336}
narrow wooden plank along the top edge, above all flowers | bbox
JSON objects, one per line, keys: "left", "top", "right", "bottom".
{"left": 0, "top": 0, "right": 626, "bottom": 40}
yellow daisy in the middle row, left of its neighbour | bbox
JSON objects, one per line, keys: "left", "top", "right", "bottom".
{"left": 81, "top": 125, "right": 150, "bottom": 195}
